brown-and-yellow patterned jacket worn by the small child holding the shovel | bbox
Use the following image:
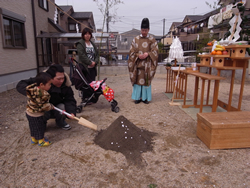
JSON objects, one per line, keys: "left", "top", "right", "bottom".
{"left": 26, "top": 83, "right": 53, "bottom": 116}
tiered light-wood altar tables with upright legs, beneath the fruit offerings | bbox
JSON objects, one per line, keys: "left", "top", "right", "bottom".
{"left": 166, "top": 45, "right": 250, "bottom": 112}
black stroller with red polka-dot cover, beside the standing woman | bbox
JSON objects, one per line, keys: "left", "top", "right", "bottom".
{"left": 70, "top": 58, "right": 120, "bottom": 113}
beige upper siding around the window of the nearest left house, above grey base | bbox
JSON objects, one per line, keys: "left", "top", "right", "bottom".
{"left": 0, "top": 0, "right": 37, "bottom": 76}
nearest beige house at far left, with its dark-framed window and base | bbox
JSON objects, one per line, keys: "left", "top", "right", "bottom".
{"left": 0, "top": 0, "right": 38, "bottom": 92}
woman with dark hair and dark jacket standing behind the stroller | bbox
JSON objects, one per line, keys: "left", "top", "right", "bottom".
{"left": 76, "top": 27, "right": 99, "bottom": 83}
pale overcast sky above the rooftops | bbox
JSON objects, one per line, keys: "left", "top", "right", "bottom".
{"left": 55, "top": 0, "right": 217, "bottom": 35}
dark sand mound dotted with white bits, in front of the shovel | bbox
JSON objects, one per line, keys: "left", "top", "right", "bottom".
{"left": 94, "top": 116, "right": 156, "bottom": 166}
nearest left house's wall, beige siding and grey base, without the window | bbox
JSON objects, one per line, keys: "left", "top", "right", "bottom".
{"left": 0, "top": 0, "right": 37, "bottom": 92}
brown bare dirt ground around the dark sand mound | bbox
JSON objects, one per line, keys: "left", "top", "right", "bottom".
{"left": 0, "top": 70, "right": 250, "bottom": 188}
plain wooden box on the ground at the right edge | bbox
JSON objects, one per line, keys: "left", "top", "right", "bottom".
{"left": 196, "top": 111, "right": 250, "bottom": 149}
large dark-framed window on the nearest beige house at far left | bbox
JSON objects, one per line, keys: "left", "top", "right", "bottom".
{"left": 0, "top": 8, "right": 26, "bottom": 48}
